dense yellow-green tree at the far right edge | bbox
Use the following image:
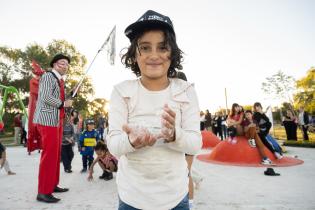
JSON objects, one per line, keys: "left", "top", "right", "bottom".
{"left": 294, "top": 67, "right": 315, "bottom": 113}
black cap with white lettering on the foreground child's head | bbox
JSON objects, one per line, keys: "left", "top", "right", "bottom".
{"left": 125, "top": 10, "right": 175, "bottom": 41}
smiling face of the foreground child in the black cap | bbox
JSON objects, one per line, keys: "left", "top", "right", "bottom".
{"left": 136, "top": 30, "right": 171, "bottom": 80}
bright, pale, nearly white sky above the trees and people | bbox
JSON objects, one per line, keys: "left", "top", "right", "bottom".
{"left": 0, "top": 0, "right": 315, "bottom": 112}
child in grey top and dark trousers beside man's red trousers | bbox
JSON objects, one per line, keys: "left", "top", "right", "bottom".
{"left": 61, "top": 117, "right": 74, "bottom": 173}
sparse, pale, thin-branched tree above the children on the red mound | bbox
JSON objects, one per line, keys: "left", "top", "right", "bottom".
{"left": 262, "top": 71, "right": 296, "bottom": 104}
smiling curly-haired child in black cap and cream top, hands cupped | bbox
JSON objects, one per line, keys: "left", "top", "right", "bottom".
{"left": 108, "top": 10, "right": 202, "bottom": 210}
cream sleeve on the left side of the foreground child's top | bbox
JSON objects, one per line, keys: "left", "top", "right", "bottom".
{"left": 107, "top": 88, "right": 135, "bottom": 158}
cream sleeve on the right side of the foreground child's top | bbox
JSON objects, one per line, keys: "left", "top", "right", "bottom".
{"left": 168, "top": 86, "right": 202, "bottom": 155}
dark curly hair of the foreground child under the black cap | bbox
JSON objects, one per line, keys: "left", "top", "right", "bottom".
{"left": 121, "top": 27, "right": 183, "bottom": 77}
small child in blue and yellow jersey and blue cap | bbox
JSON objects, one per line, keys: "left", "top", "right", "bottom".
{"left": 79, "top": 119, "right": 99, "bottom": 173}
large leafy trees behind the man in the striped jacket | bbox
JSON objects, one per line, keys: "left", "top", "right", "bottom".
{"left": 0, "top": 40, "right": 94, "bottom": 115}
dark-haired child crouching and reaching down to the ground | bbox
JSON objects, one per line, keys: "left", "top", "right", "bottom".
{"left": 88, "top": 141, "right": 118, "bottom": 181}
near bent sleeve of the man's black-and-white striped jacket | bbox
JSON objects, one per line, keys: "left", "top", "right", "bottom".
{"left": 39, "top": 74, "right": 63, "bottom": 108}
